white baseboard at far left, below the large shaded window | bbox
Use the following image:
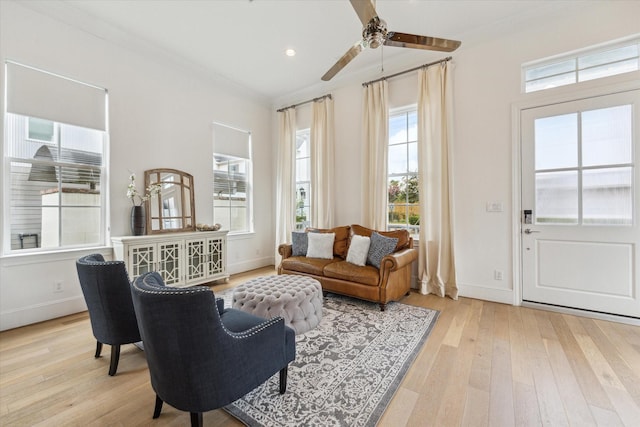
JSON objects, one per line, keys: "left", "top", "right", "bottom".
{"left": 0, "top": 295, "right": 87, "bottom": 331}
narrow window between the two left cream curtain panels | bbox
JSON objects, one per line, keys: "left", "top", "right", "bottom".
{"left": 295, "top": 129, "right": 311, "bottom": 230}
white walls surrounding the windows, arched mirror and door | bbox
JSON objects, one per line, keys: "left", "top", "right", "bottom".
{"left": 0, "top": 1, "right": 640, "bottom": 329}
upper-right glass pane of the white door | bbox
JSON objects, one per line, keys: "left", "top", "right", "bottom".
{"left": 582, "top": 105, "right": 632, "bottom": 166}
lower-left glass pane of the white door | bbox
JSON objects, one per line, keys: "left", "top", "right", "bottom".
{"left": 535, "top": 171, "right": 578, "bottom": 224}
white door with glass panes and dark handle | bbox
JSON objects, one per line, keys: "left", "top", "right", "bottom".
{"left": 521, "top": 90, "right": 640, "bottom": 317}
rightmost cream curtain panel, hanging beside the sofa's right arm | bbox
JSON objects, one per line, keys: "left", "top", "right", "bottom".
{"left": 418, "top": 62, "right": 458, "bottom": 299}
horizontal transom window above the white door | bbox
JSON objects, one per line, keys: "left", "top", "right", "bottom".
{"left": 522, "top": 39, "right": 640, "bottom": 93}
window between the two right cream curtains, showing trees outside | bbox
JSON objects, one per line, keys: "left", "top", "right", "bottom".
{"left": 387, "top": 106, "right": 420, "bottom": 234}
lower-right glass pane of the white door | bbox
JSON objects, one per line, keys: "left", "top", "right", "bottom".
{"left": 582, "top": 167, "right": 633, "bottom": 225}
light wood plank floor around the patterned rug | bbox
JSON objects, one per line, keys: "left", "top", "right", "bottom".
{"left": 0, "top": 268, "right": 640, "bottom": 427}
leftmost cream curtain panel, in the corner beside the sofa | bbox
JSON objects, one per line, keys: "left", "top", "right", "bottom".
{"left": 275, "top": 108, "right": 296, "bottom": 265}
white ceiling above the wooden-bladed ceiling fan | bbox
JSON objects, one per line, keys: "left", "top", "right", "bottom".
{"left": 39, "top": 0, "right": 567, "bottom": 102}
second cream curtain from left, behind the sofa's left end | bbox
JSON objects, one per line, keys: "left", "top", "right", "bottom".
{"left": 311, "top": 97, "right": 335, "bottom": 228}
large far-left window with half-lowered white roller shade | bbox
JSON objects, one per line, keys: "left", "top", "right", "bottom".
{"left": 3, "top": 63, "right": 107, "bottom": 253}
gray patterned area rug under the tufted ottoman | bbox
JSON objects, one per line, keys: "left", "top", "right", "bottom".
{"left": 219, "top": 292, "right": 439, "bottom": 427}
